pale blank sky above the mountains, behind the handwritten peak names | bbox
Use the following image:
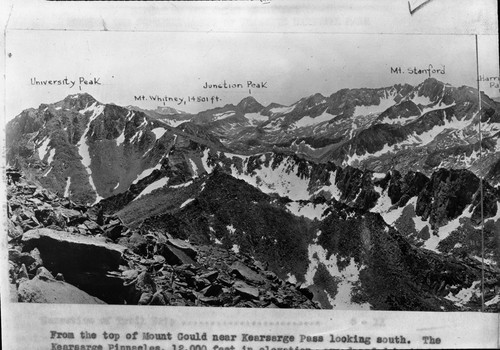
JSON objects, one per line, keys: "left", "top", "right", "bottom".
{"left": 6, "top": 30, "right": 500, "bottom": 119}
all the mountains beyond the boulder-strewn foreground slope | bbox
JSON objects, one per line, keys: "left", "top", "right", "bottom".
{"left": 6, "top": 79, "right": 500, "bottom": 310}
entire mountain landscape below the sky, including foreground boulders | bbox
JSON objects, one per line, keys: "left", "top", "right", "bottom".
{"left": 6, "top": 77, "right": 500, "bottom": 312}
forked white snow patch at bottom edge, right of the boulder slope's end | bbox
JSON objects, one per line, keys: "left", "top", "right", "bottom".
{"left": 303, "top": 244, "right": 371, "bottom": 310}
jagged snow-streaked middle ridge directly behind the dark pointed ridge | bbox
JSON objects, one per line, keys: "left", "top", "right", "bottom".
{"left": 98, "top": 147, "right": 500, "bottom": 261}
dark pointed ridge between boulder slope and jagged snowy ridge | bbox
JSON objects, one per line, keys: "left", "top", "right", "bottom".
{"left": 97, "top": 167, "right": 498, "bottom": 311}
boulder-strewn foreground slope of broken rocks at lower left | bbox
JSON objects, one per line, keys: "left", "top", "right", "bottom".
{"left": 7, "top": 169, "right": 318, "bottom": 308}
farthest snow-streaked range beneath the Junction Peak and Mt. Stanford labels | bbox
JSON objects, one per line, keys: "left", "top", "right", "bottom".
{"left": 162, "top": 78, "right": 500, "bottom": 185}
